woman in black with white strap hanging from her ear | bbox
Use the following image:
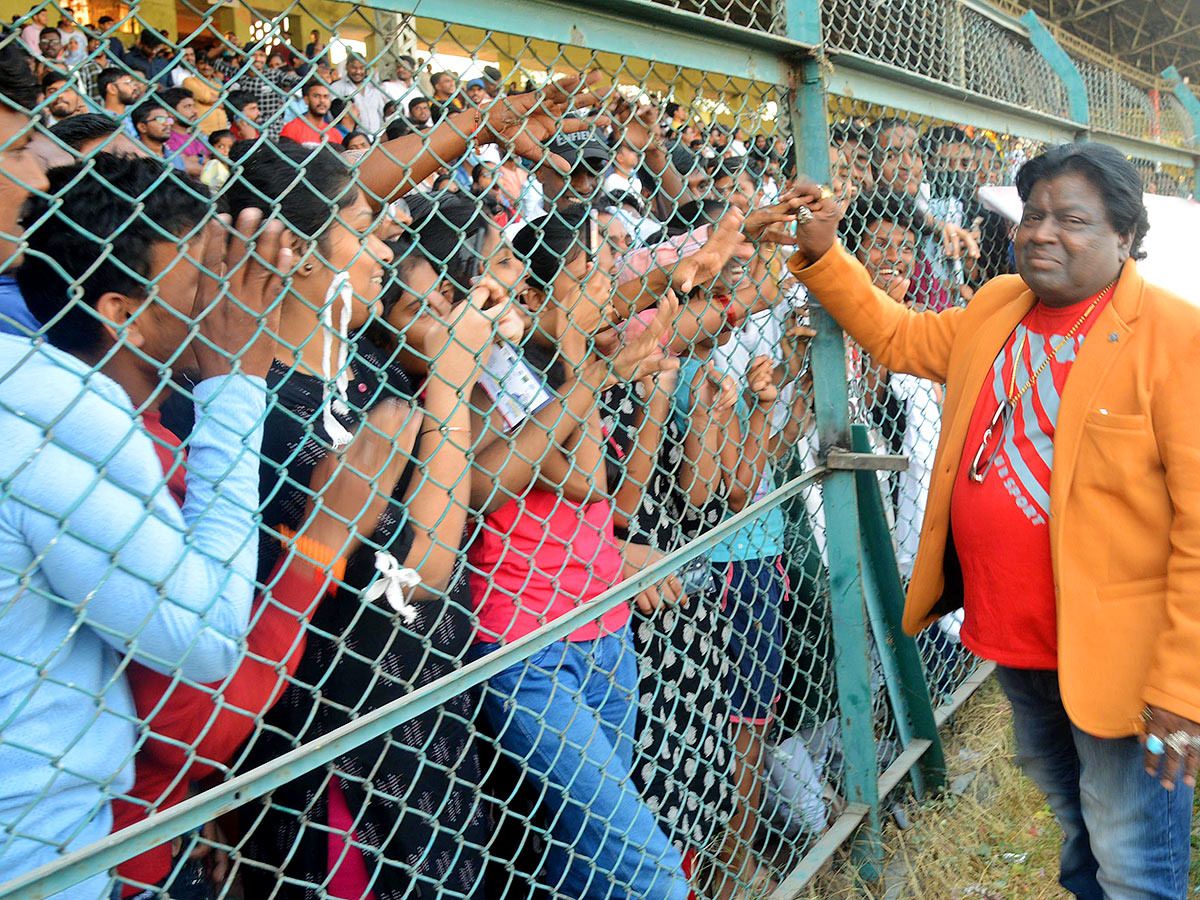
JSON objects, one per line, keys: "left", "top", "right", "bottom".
{"left": 228, "top": 144, "right": 511, "bottom": 900}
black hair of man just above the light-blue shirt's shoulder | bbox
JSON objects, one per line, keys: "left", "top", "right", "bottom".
{"left": 17, "top": 154, "right": 212, "bottom": 359}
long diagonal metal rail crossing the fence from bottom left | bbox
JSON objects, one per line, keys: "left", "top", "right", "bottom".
{"left": 0, "top": 467, "right": 826, "bottom": 900}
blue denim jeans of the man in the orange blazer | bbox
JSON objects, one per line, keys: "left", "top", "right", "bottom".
{"left": 996, "top": 666, "right": 1193, "bottom": 900}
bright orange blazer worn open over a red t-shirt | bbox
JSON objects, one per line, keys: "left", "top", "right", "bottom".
{"left": 790, "top": 245, "right": 1200, "bottom": 737}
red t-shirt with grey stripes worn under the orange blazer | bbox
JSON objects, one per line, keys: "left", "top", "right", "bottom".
{"left": 950, "top": 289, "right": 1112, "bottom": 670}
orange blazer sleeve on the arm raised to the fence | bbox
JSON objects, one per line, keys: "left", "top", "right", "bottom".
{"left": 787, "top": 242, "right": 966, "bottom": 383}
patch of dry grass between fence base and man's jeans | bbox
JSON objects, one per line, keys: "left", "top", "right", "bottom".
{"left": 800, "top": 680, "right": 1198, "bottom": 900}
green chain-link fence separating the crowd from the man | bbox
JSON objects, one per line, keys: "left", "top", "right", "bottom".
{"left": 0, "top": 0, "right": 1194, "bottom": 900}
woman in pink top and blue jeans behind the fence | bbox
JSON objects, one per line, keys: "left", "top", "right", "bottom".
{"left": 468, "top": 206, "right": 689, "bottom": 900}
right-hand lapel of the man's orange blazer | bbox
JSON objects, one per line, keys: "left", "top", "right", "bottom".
{"left": 1050, "top": 259, "right": 1145, "bottom": 518}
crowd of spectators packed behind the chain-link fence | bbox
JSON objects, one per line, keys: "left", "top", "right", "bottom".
{"left": 0, "top": 11, "right": 1118, "bottom": 900}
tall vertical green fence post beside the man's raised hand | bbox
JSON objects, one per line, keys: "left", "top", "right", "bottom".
{"left": 784, "top": 0, "right": 883, "bottom": 877}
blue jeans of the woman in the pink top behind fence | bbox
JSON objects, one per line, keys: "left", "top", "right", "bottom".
{"left": 472, "top": 628, "right": 688, "bottom": 900}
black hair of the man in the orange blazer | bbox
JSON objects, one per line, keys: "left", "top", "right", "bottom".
{"left": 1016, "top": 140, "right": 1150, "bottom": 259}
